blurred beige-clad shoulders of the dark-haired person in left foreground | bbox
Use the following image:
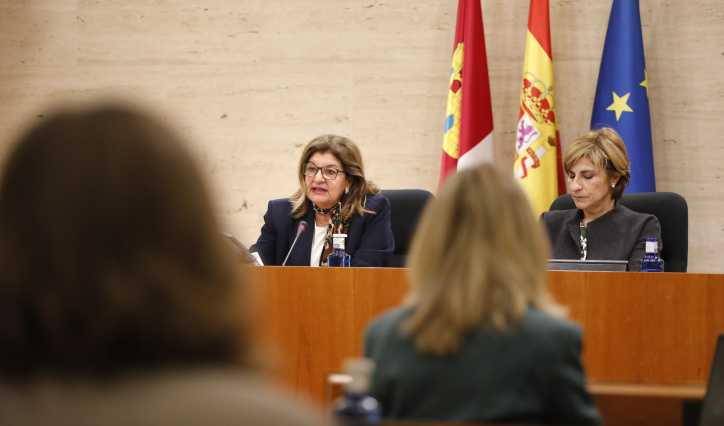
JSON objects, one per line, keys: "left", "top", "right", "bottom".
{"left": 0, "top": 367, "right": 327, "bottom": 426}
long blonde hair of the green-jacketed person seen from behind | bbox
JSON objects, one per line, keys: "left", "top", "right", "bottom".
{"left": 402, "top": 165, "right": 564, "bottom": 355}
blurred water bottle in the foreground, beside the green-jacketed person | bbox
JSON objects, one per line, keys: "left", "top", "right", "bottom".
{"left": 332, "top": 358, "right": 382, "bottom": 426}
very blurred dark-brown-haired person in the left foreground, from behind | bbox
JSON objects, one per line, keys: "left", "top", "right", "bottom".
{"left": 0, "top": 105, "right": 320, "bottom": 426}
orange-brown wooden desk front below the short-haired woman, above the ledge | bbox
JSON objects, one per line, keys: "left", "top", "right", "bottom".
{"left": 549, "top": 271, "right": 724, "bottom": 383}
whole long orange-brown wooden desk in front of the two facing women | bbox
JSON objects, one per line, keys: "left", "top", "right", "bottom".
{"left": 245, "top": 266, "right": 724, "bottom": 425}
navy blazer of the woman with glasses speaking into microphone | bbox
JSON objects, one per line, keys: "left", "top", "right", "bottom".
{"left": 249, "top": 195, "right": 395, "bottom": 266}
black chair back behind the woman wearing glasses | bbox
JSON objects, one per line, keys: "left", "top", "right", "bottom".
{"left": 382, "top": 189, "right": 433, "bottom": 268}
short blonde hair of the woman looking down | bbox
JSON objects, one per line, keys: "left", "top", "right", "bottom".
{"left": 563, "top": 127, "right": 631, "bottom": 200}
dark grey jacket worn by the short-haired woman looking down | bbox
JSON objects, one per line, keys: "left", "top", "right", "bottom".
{"left": 540, "top": 203, "right": 663, "bottom": 271}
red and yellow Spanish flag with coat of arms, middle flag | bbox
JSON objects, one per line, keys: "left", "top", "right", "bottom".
{"left": 513, "top": 0, "right": 566, "bottom": 215}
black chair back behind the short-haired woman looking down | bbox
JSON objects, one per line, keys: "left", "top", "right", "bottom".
{"left": 549, "top": 192, "right": 689, "bottom": 272}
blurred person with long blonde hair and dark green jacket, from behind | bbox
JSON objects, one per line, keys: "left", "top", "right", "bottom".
{"left": 364, "top": 165, "right": 600, "bottom": 425}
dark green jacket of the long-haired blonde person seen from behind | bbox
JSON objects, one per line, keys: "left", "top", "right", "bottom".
{"left": 364, "top": 309, "right": 600, "bottom": 425}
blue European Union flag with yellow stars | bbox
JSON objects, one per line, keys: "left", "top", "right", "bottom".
{"left": 591, "top": 0, "right": 656, "bottom": 192}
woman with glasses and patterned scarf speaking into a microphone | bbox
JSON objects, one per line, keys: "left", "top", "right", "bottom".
{"left": 249, "top": 135, "right": 395, "bottom": 267}
